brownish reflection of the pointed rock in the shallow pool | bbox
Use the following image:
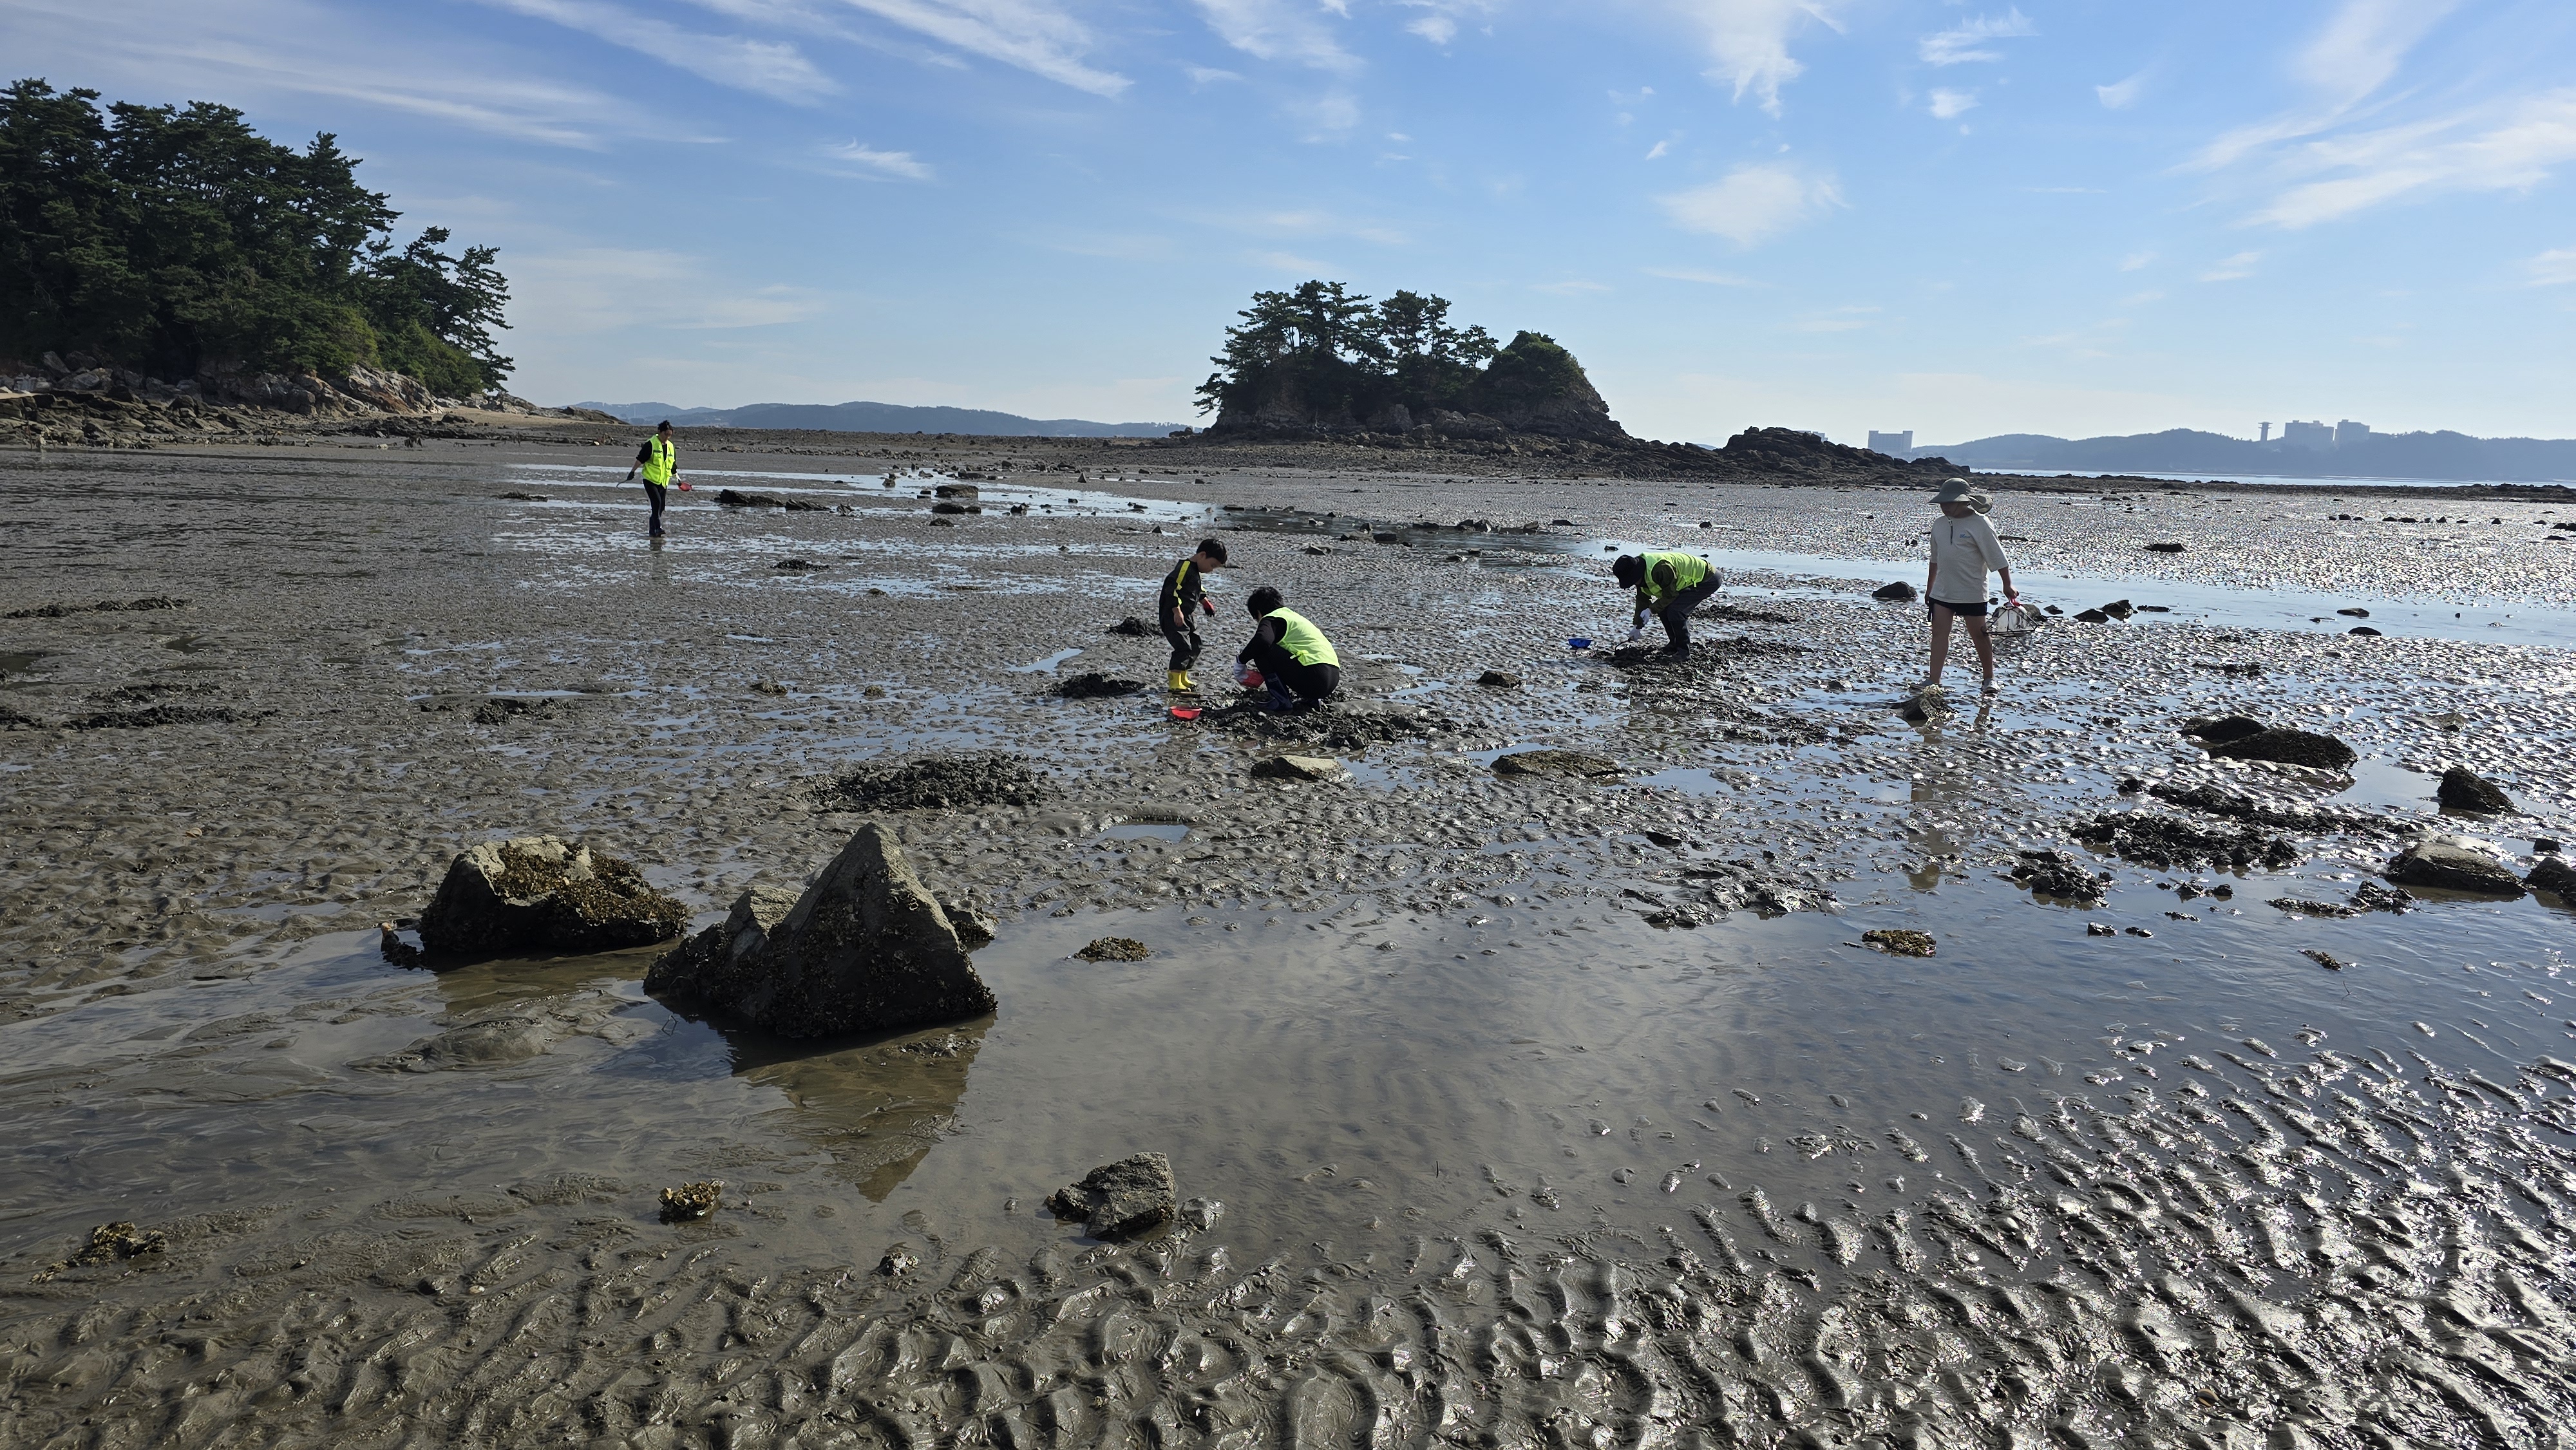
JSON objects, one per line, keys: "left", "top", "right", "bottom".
{"left": 724, "top": 1017, "right": 992, "bottom": 1203}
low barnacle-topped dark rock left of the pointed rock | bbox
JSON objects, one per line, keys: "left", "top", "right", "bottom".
{"left": 420, "top": 837, "right": 688, "bottom": 961}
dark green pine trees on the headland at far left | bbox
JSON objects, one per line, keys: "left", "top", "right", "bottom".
{"left": 0, "top": 80, "right": 510, "bottom": 397}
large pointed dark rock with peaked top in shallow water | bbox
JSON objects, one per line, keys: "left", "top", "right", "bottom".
{"left": 644, "top": 822, "right": 994, "bottom": 1038}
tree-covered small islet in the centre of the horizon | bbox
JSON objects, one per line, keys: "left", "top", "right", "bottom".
{"left": 1198, "top": 281, "right": 1623, "bottom": 435}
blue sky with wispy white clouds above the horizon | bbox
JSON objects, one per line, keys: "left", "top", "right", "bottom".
{"left": 0, "top": 0, "right": 2576, "bottom": 443}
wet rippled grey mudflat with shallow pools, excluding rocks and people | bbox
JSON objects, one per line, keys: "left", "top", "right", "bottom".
{"left": 0, "top": 446, "right": 2576, "bottom": 1445}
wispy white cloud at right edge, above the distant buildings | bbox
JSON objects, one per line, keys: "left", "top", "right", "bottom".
{"left": 2249, "top": 88, "right": 2576, "bottom": 229}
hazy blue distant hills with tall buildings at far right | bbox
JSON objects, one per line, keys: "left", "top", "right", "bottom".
{"left": 1906, "top": 428, "right": 2576, "bottom": 484}
